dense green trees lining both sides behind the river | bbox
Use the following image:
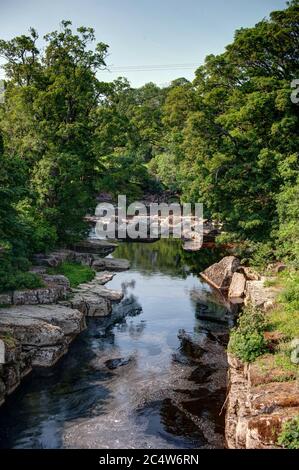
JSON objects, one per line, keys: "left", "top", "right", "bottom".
{"left": 0, "top": 0, "right": 299, "bottom": 290}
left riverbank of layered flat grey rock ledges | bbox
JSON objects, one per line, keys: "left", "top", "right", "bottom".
{"left": 0, "top": 241, "right": 129, "bottom": 406}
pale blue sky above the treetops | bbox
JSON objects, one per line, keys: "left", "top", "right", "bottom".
{"left": 0, "top": 0, "right": 286, "bottom": 86}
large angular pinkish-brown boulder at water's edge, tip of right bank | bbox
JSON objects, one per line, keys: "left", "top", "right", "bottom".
{"left": 201, "top": 256, "right": 240, "bottom": 290}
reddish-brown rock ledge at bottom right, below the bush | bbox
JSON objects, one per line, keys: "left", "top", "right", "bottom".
{"left": 225, "top": 354, "right": 299, "bottom": 449}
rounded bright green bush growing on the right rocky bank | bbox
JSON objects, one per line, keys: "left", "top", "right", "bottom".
{"left": 228, "top": 307, "right": 267, "bottom": 362}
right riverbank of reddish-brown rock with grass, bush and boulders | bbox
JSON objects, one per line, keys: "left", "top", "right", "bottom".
{"left": 203, "top": 257, "right": 299, "bottom": 449}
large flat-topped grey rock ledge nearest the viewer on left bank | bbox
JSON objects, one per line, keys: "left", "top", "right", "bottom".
{"left": 0, "top": 305, "right": 86, "bottom": 405}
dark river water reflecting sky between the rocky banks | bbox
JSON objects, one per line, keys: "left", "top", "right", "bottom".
{"left": 0, "top": 240, "right": 231, "bottom": 449}
